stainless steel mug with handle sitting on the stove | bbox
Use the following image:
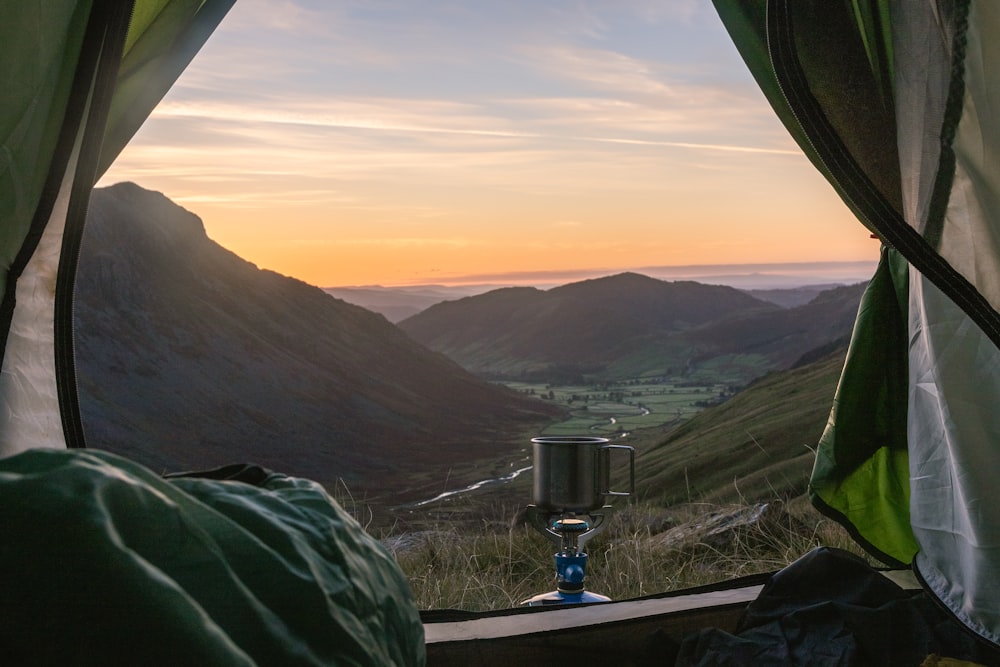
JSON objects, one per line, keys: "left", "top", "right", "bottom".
{"left": 531, "top": 436, "right": 635, "bottom": 514}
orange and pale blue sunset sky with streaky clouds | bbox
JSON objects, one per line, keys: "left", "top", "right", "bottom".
{"left": 100, "top": 0, "right": 878, "bottom": 287}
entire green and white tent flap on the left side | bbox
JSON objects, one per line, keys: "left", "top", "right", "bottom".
{"left": 0, "top": 0, "right": 233, "bottom": 455}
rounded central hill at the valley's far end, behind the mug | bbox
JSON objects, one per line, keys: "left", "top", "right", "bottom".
{"left": 399, "top": 273, "right": 779, "bottom": 378}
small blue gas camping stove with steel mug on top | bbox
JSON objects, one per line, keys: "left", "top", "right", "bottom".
{"left": 522, "top": 436, "right": 635, "bottom": 606}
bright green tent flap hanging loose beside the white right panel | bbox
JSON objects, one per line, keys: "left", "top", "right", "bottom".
{"left": 809, "top": 249, "right": 917, "bottom": 566}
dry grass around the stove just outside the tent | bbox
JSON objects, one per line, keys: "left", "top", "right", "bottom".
{"left": 383, "top": 499, "right": 861, "bottom": 611}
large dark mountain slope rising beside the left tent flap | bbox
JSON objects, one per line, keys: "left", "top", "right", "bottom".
{"left": 75, "top": 183, "right": 556, "bottom": 494}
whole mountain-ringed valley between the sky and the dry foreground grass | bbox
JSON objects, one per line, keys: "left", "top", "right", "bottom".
{"left": 76, "top": 184, "right": 862, "bottom": 526}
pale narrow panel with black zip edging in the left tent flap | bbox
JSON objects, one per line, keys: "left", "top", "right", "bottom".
{"left": 6, "top": 2, "right": 137, "bottom": 456}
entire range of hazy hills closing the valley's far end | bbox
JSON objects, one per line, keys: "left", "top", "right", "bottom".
{"left": 399, "top": 273, "right": 862, "bottom": 381}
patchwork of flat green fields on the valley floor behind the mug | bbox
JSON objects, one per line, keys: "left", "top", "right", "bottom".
{"left": 505, "top": 378, "right": 736, "bottom": 437}
